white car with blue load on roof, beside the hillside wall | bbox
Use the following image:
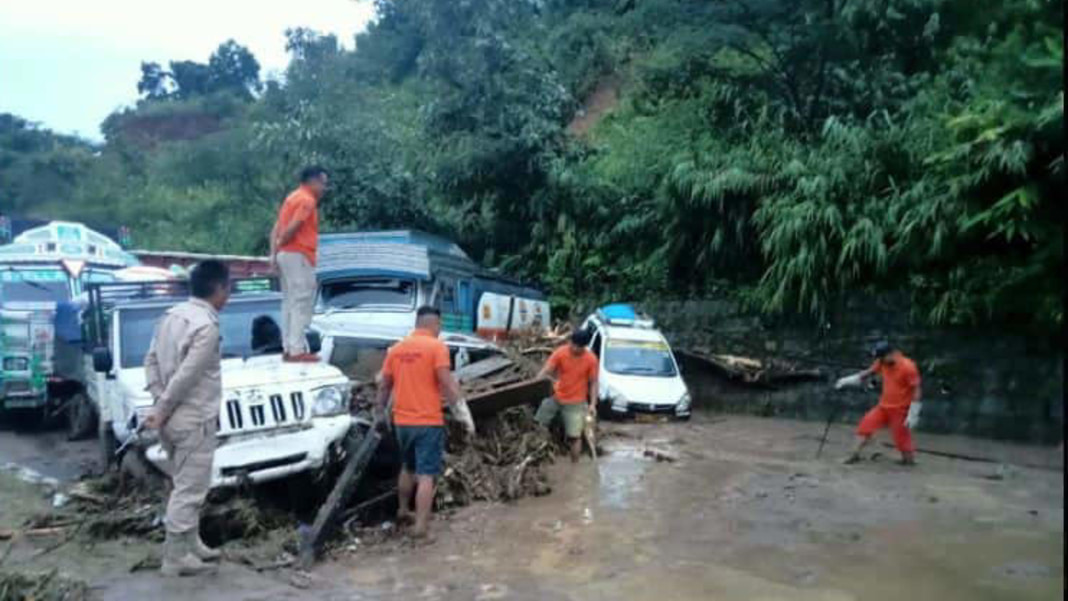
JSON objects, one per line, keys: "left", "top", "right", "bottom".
{"left": 582, "top": 304, "right": 691, "bottom": 420}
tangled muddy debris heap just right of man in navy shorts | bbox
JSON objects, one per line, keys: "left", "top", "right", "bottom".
{"left": 436, "top": 406, "right": 565, "bottom": 508}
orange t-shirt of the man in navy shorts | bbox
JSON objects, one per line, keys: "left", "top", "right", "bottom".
{"left": 382, "top": 330, "right": 449, "bottom": 426}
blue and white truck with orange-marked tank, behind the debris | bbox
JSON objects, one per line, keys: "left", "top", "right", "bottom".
{"left": 312, "top": 230, "right": 542, "bottom": 381}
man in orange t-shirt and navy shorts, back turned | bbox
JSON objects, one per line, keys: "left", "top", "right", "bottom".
{"left": 375, "top": 306, "right": 474, "bottom": 538}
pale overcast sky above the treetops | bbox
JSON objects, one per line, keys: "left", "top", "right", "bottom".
{"left": 0, "top": 0, "right": 374, "bottom": 140}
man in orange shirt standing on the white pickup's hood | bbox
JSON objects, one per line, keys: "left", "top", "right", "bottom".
{"left": 270, "top": 165, "right": 328, "bottom": 362}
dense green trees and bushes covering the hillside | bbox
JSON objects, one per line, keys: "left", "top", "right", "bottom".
{"left": 0, "top": 0, "right": 1065, "bottom": 328}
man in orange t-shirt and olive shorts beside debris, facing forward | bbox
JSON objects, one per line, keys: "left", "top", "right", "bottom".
{"left": 534, "top": 330, "right": 598, "bottom": 462}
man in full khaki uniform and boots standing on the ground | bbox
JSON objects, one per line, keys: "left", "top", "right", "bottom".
{"left": 143, "top": 260, "right": 230, "bottom": 575}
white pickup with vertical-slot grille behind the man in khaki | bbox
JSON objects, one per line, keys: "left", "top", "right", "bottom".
{"left": 87, "top": 282, "right": 355, "bottom": 487}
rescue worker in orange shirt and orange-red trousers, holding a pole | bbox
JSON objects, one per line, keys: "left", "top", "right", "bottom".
{"left": 834, "top": 341, "right": 923, "bottom": 465}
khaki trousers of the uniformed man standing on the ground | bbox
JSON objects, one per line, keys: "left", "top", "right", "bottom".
{"left": 160, "top": 420, "right": 217, "bottom": 534}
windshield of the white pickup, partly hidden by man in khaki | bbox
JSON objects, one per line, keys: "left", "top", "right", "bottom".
{"left": 121, "top": 300, "right": 282, "bottom": 367}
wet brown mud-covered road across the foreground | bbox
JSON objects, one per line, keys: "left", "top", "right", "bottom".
{"left": 0, "top": 415, "right": 1065, "bottom": 601}
